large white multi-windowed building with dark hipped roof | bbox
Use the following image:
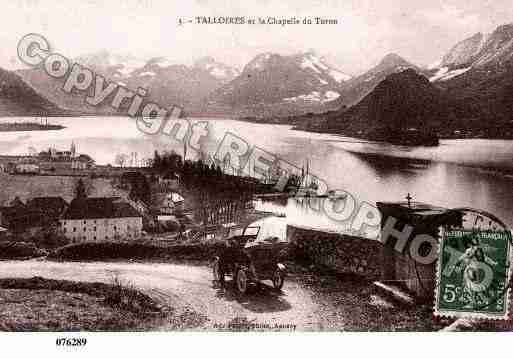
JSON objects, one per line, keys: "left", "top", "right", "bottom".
{"left": 60, "top": 198, "right": 142, "bottom": 242}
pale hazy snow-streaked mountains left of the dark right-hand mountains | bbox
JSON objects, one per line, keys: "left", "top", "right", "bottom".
{"left": 18, "top": 50, "right": 351, "bottom": 114}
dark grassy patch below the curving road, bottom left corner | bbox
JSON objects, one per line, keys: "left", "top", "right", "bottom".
{"left": 0, "top": 277, "right": 202, "bottom": 331}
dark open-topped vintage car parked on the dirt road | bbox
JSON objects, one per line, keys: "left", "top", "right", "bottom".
{"left": 213, "top": 219, "right": 287, "bottom": 294}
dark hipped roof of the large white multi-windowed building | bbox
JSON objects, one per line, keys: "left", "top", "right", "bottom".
{"left": 63, "top": 197, "right": 142, "bottom": 219}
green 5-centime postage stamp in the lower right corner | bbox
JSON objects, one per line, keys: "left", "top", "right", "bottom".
{"left": 435, "top": 230, "right": 511, "bottom": 319}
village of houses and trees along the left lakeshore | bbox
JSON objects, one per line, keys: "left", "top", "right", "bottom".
{"left": 0, "top": 143, "right": 272, "bottom": 250}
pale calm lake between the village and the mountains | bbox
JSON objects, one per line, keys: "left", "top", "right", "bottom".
{"left": 0, "top": 117, "right": 513, "bottom": 230}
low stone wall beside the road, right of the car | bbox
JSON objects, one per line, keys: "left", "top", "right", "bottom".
{"left": 287, "top": 225, "right": 383, "bottom": 280}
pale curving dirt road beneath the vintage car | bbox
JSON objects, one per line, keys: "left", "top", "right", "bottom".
{"left": 0, "top": 260, "right": 321, "bottom": 330}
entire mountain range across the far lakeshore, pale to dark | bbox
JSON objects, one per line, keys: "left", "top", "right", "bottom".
{"left": 2, "top": 20, "right": 513, "bottom": 142}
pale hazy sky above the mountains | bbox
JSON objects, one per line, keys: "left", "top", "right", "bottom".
{"left": 0, "top": 0, "right": 513, "bottom": 75}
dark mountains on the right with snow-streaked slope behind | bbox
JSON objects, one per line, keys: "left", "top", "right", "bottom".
{"left": 289, "top": 24, "right": 513, "bottom": 140}
